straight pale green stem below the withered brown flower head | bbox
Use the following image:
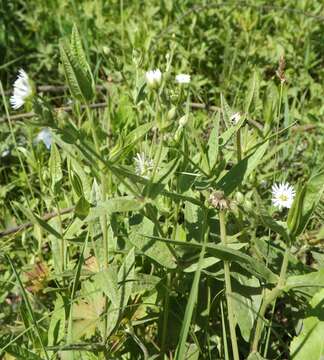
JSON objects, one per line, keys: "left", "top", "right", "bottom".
{"left": 219, "top": 210, "right": 240, "bottom": 360}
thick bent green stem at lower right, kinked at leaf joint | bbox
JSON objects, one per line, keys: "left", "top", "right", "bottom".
{"left": 251, "top": 246, "right": 290, "bottom": 352}
